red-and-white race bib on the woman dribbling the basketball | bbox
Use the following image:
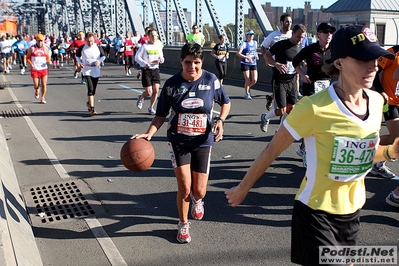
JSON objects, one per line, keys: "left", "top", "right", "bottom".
{"left": 177, "top": 113, "right": 208, "bottom": 136}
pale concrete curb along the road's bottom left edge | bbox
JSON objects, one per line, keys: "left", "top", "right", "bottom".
{"left": 0, "top": 125, "right": 43, "bottom": 266}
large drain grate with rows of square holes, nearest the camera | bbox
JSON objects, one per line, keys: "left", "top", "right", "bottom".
{"left": 24, "top": 180, "right": 103, "bottom": 224}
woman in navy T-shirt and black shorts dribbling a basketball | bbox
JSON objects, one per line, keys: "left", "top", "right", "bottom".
{"left": 132, "top": 43, "right": 230, "bottom": 243}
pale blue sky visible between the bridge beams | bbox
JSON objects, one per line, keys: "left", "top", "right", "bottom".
{"left": 142, "top": 0, "right": 337, "bottom": 26}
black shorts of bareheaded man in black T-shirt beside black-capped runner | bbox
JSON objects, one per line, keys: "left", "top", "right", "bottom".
{"left": 274, "top": 77, "right": 298, "bottom": 109}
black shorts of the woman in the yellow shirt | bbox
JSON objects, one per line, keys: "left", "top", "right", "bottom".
{"left": 291, "top": 200, "right": 360, "bottom": 265}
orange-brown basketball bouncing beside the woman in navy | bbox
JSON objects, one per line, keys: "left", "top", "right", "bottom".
{"left": 120, "top": 139, "right": 155, "bottom": 172}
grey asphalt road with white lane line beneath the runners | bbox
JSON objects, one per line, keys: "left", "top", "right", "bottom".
{"left": 0, "top": 62, "right": 399, "bottom": 266}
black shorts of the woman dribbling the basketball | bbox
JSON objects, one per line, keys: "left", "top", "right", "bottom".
{"left": 168, "top": 142, "right": 212, "bottom": 174}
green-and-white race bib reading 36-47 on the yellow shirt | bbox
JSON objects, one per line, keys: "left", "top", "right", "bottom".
{"left": 328, "top": 137, "right": 378, "bottom": 182}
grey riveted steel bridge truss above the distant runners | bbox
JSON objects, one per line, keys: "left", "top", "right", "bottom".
{"left": 14, "top": 0, "right": 272, "bottom": 47}
